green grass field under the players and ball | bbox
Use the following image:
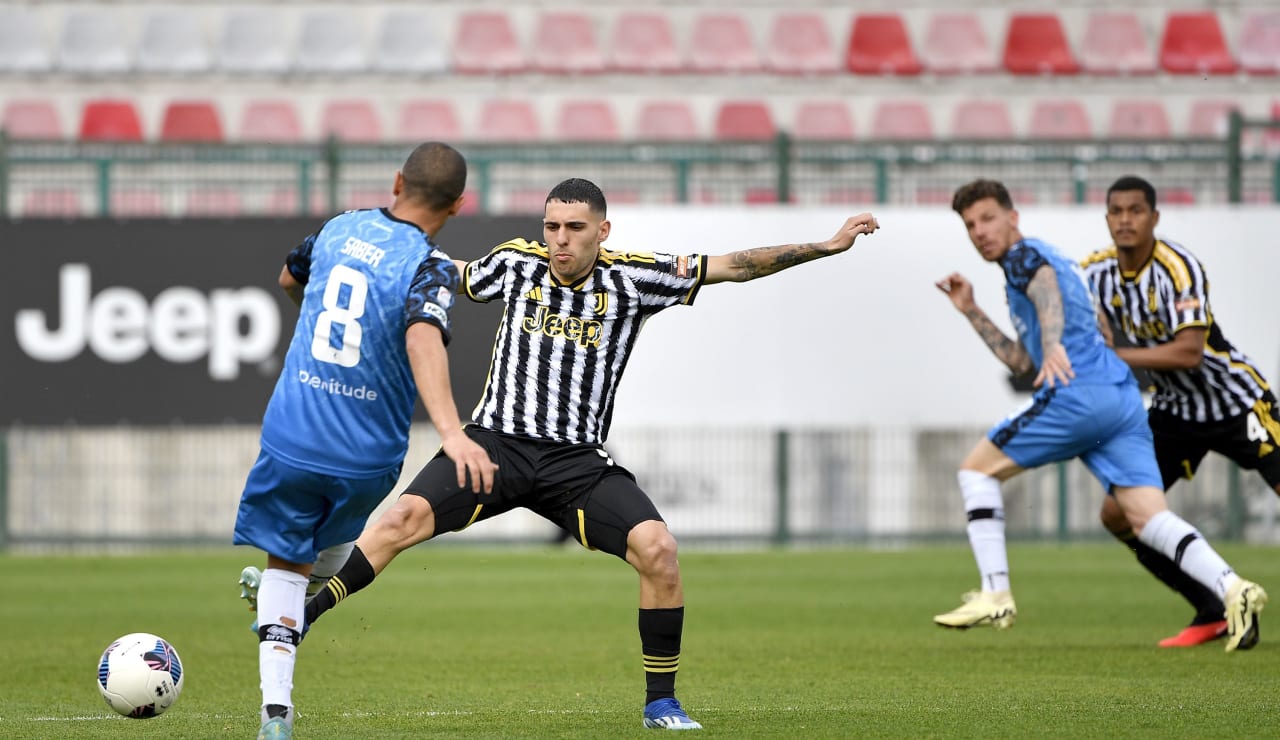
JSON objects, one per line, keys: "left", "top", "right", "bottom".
{"left": 0, "top": 544, "right": 1280, "bottom": 740}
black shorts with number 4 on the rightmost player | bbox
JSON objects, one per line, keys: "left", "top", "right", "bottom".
{"left": 1148, "top": 390, "right": 1280, "bottom": 490}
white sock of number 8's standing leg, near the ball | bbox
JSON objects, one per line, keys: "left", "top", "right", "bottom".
{"left": 257, "top": 568, "right": 307, "bottom": 706}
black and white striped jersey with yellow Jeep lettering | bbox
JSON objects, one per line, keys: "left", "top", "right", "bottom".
{"left": 462, "top": 239, "right": 707, "bottom": 443}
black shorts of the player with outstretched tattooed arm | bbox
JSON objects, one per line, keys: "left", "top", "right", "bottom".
{"left": 404, "top": 425, "right": 663, "bottom": 559}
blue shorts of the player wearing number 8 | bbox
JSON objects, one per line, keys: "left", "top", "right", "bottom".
{"left": 234, "top": 451, "right": 399, "bottom": 563}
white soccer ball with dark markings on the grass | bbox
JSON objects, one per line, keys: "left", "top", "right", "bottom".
{"left": 97, "top": 632, "right": 183, "bottom": 720}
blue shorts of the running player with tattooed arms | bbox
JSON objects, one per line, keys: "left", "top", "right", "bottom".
{"left": 987, "top": 382, "right": 1165, "bottom": 493}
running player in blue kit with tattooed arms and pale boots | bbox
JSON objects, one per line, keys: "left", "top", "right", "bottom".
{"left": 933, "top": 179, "right": 1267, "bottom": 652}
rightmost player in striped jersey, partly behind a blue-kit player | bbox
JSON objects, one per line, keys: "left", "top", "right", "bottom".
{"left": 1084, "top": 175, "right": 1280, "bottom": 648}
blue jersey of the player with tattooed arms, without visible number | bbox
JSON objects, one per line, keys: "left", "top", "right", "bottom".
{"left": 1000, "top": 239, "right": 1137, "bottom": 384}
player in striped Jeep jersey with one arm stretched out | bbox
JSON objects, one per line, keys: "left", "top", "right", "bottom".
{"left": 306, "top": 179, "right": 877, "bottom": 730}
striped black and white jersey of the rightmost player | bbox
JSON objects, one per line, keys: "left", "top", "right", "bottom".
{"left": 1083, "top": 239, "right": 1267, "bottom": 421}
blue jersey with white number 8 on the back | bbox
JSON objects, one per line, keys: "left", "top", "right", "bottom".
{"left": 262, "top": 209, "right": 458, "bottom": 478}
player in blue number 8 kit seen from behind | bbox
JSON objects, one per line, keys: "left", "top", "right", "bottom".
{"left": 234, "top": 143, "right": 494, "bottom": 739}
